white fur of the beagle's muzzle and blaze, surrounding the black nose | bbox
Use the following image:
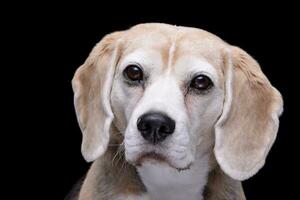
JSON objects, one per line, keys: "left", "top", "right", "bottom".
{"left": 125, "top": 77, "right": 195, "bottom": 168}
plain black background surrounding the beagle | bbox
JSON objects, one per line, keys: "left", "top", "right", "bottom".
{"left": 8, "top": 2, "right": 299, "bottom": 199}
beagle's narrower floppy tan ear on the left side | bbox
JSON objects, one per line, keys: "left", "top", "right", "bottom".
{"left": 72, "top": 32, "right": 121, "bottom": 162}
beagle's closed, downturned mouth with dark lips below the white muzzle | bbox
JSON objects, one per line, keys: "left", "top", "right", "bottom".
{"left": 134, "top": 152, "right": 192, "bottom": 171}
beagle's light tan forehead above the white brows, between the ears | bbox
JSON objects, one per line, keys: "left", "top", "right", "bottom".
{"left": 120, "top": 23, "right": 227, "bottom": 72}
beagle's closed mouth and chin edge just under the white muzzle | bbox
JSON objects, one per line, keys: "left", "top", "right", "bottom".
{"left": 131, "top": 152, "right": 192, "bottom": 171}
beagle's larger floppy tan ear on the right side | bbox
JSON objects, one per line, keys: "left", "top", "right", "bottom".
{"left": 214, "top": 47, "right": 283, "bottom": 180}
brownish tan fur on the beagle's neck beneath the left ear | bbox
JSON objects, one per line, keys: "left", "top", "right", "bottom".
{"left": 79, "top": 125, "right": 145, "bottom": 200}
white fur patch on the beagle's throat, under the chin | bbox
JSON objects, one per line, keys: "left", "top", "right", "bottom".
{"left": 137, "top": 156, "right": 209, "bottom": 200}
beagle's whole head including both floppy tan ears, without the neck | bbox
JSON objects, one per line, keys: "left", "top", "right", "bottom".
{"left": 72, "top": 24, "right": 282, "bottom": 180}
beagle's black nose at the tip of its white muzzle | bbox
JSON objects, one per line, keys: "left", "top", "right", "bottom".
{"left": 137, "top": 113, "right": 175, "bottom": 144}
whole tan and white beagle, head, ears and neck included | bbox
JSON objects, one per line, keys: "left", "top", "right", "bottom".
{"left": 72, "top": 23, "right": 283, "bottom": 200}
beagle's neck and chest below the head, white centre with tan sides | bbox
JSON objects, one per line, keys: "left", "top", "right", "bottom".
{"left": 77, "top": 143, "right": 245, "bottom": 200}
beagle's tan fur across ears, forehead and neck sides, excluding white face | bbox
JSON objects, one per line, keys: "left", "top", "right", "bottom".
{"left": 72, "top": 24, "right": 282, "bottom": 200}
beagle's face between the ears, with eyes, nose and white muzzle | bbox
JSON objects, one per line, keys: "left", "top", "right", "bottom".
{"left": 111, "top": 28, "right": 224, "bottom": 169}
